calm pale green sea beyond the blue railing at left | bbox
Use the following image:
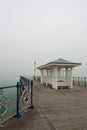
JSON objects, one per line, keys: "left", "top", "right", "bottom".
{"left": 0, "top": 76, "right": 32, "bottom": 100}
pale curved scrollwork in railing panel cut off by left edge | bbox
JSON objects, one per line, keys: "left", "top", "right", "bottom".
{"left": 0, "top": 95, "right": 8, "bottom": 116}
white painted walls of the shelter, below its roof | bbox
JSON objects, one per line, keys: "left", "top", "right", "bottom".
{"left": 41, "top": 67, "right": 73, "bottom": 89}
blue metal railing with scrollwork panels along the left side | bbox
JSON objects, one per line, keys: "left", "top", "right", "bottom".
{"left": 0, "top": 76, "right": 33, "bottom": 125}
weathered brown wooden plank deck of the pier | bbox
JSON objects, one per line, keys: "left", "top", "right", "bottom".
{"left": 0, "top": 82, "right": 87, "bottom": 130}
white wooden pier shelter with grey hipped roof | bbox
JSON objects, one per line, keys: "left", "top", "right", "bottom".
{"left": 37, "top": 58, "right": 81, "bottom": 89}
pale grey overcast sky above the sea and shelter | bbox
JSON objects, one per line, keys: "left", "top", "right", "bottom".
{"left": 0, "top": 0, "right": 87, "bottom": 76}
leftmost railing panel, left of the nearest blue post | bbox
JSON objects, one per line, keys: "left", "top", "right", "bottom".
{"left": 0, "top": 86, "right": 16, "bottom": 124}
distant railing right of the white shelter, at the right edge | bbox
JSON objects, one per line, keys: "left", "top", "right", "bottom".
{"left": 73, "top": 77, "right": 87, "bottom": 86}
